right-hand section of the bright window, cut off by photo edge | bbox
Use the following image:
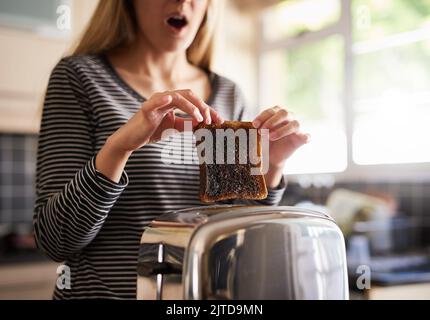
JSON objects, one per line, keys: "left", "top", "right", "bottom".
{"left": 352, "top": 0, "right": 430, "bottom": 164}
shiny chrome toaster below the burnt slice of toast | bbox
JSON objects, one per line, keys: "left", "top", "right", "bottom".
{"left": 137, "top": 205, "right": 348, "bottom": 300}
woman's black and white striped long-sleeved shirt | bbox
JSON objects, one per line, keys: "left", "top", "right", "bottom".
{"left": 34, "top": 55, "right": 285, "bottom": 299}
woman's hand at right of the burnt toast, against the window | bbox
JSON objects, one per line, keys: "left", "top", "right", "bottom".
{"left": 252, "top": 106, "right": 310, "bottom": 185}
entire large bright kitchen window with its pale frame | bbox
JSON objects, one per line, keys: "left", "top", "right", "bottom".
{"left": 259, "top": 0, "right": 430, "bottom": 174}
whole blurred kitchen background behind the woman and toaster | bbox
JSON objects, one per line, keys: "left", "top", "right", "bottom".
{"left": 0, "top": 0, "right": 430, "bottom": 299}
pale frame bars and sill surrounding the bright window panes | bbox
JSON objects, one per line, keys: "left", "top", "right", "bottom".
{"left": 256, "top": 0, "right": 430, "bottom": 182}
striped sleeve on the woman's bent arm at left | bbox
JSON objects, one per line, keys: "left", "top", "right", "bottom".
{"left": 33, "top": 60, "right": 128, "bottom": 261}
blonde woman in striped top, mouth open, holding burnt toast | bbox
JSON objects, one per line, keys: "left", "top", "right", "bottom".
{"left": 34, "top": 0, "right": 307, "bottom": 299}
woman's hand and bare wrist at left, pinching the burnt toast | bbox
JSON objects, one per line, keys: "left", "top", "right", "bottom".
{"left": 96, "top": 90, "right": 224, "bottom": 182}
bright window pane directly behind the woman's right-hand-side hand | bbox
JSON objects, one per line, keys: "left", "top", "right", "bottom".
{"left": 261, "top": 36, "right": 347, "bottom": 174}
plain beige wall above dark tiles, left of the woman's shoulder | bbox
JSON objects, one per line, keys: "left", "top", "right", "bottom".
{"left": 0, "top": 0, "right": 97, "bottom": 132}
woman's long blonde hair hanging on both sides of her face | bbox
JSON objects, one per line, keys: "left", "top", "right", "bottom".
{"left": 72, "top": 0, "right": 221, "bottom": 70}
